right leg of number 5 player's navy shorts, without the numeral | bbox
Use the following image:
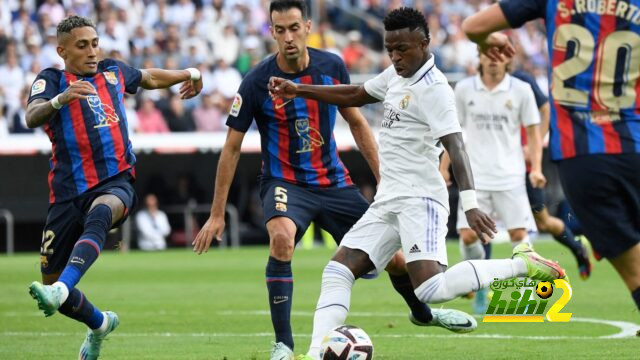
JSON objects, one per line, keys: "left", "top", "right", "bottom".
{"left": 316, "top": 186, "right": 369, "bottom": 244}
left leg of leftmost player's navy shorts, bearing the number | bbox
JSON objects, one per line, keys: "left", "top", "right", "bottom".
{"left": 40, "top": 201, "right": 84, "bottom": 279}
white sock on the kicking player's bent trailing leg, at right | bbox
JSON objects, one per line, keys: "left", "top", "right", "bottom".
{"left": 415, "top": 258, "right": 527, "bottom": 304}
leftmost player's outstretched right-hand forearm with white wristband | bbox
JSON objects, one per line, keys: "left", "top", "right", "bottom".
{"left": 140, "top": 68, "right": 202, "bottom": 99}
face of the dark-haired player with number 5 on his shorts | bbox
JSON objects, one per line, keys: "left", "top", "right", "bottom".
{"left": 271, "top": 8, "right": 311, "bottom": 60}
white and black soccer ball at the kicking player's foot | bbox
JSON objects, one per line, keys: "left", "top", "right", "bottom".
{"left": 320, "top": 325, "right": 373, "bottom": 360}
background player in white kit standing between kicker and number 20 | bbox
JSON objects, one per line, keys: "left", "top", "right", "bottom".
{"left": 445, "top": 47, "right": 546, "bottom": 313}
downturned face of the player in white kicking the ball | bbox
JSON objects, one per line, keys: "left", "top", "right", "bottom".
{"left": 384, "top": 28, "right": 429, "bottom": 78}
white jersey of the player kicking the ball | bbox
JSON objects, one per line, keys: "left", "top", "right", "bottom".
{"left": 364, "top": 55, "right": 461, "bottom": 209}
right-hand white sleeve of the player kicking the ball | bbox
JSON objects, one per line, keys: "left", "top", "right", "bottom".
{"left": 421, "top": 82, "right": 462, "bottom": 139}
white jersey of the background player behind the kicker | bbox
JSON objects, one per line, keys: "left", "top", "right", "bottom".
{"left": 455, "top": 74, "right": 540, "bottom": 191}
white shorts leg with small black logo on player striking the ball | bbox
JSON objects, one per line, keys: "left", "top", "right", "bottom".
{"left": 398, "top": 197, "right": 449, "bottom": 268}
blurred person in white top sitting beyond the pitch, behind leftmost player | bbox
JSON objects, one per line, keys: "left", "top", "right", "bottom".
{"left": 136, "top": 194, "right": 171, "bottom": 251}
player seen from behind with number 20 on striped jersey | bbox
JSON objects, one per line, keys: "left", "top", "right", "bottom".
{"left": 463, "top": 0, "right": 640, "bottom": 309}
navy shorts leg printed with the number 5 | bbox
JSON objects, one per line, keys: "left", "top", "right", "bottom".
{"left": 260, "top": 180, "right": 321, "bottom": 242}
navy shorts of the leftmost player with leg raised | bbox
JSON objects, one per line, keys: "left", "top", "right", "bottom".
{"left": 40, "top": 172, "right": 138, "bottom": 274}
